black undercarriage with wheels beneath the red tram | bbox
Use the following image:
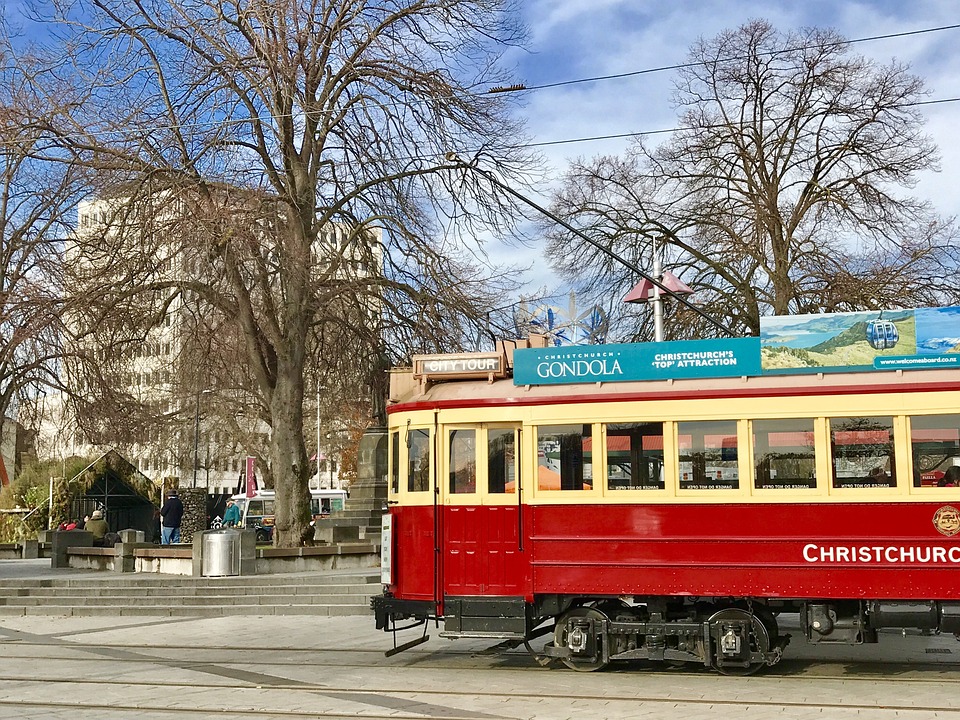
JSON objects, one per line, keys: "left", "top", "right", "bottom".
{"left": 373, "top": 595, "right": 960, "bottom": 675}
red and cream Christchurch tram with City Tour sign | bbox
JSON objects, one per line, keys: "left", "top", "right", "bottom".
{"left": 374, "top": 316, "right": 960, "bottom": 674}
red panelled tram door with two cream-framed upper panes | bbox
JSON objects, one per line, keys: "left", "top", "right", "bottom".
{"left": 440, "top": 424, "right": 524, "bottom": 596}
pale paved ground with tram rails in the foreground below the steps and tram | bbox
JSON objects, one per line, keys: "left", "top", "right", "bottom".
{"left": 0, "top": 561, "right": 960, "bottom": 720}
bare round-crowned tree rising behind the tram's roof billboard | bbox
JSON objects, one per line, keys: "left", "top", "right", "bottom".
{"left": 549, "top": 21, "right": 960, "bottom": 337}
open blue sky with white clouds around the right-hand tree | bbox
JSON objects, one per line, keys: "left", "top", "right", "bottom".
{"left": 510, "top": 0, "right": 960, "bottom": 289}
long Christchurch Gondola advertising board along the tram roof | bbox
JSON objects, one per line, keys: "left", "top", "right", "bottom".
{"left": 514, "top": 307, "right": 960, "bottom": 385}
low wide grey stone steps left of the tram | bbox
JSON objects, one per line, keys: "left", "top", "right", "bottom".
{"left": 0, "top": 569, "right": 381, "bottom": 617}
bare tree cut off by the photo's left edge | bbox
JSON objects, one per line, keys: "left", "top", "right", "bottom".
{"left": 0, "top": 23, "right": 89, "bottom": 456}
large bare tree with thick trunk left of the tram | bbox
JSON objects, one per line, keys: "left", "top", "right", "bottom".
{"left": 37, "top": 0, "right": 528, "bottom": 546}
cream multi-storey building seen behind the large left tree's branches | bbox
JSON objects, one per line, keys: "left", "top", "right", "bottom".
{"left": 36, "top": 194, "right": 383, "bottom": 493}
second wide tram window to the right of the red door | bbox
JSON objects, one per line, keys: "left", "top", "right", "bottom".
{"left": 606, "top": 423, "right": 664, "bottom": 490}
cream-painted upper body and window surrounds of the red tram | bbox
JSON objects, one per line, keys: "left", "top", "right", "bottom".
{"left": 390, "top": 371, "right": 960, "bottom": 504}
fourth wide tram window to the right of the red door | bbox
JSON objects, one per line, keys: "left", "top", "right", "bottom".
{"left": 753, "top": 418, "right": 817, "bottom": 490}
